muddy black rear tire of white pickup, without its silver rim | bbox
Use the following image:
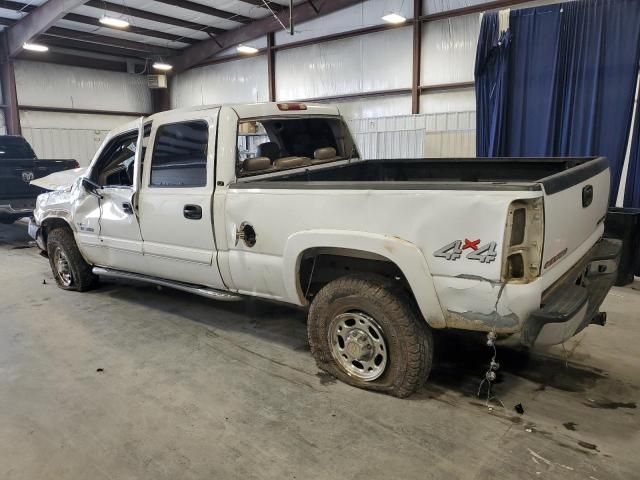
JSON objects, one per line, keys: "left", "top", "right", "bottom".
{"left": 307, "top": 274, "right": 433, "bottom": 398}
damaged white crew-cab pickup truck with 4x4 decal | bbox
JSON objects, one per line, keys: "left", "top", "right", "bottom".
{"left": 30, "top": 103, "right": 620, "bottom": 397}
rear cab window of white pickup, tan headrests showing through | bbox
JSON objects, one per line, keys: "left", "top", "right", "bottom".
{"left": 238, "top": 117, "right": 358, "bottom": 176}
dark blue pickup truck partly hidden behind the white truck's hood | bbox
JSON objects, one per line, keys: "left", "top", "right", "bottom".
{"left": 0, "top": 135, "right": 79, "bottom": 223}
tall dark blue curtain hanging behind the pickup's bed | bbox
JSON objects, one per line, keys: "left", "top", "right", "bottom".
{"left": 475, "top": 0, "right": 640, "bottom": 201}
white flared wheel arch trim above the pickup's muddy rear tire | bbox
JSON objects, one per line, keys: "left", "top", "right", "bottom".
{"left": 283, "top": 230, "right": 446, "bottom": 328}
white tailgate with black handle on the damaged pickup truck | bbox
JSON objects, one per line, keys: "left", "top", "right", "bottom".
{"left": 541, "top": 157, "right": 610, "bottom": 273}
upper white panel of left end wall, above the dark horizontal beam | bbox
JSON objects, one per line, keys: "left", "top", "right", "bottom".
{"left": 15, "top": 60, "right": 151, "bottom": 112}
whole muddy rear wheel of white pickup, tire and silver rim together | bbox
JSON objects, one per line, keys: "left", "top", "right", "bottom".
{"left": 307, "top": 275, "right": 433, "bottom": 397}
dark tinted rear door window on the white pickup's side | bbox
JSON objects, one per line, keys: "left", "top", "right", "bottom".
{"left": 150, "top": 120, "right": 209, "bottom": 187}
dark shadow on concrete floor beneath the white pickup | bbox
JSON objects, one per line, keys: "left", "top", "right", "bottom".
{"left": 97, "top": 281, "right": 607, "bottom": 399}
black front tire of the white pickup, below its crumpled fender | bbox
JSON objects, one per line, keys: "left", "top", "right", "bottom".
{"left": 47, "top": 228, "right": 97, "bottom": 292}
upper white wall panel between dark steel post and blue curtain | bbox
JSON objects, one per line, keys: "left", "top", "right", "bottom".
{"left": 420, "top": 13, "right": 480, "bottom": 85}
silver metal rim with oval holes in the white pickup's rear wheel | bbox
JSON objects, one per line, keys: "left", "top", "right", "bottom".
{"left": 328, "top": 312, "right": 388, "bottom": 382}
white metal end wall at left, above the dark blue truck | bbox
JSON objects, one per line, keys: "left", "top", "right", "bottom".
{"left": 15, "top": 61, "right": 151, "bottom": 165}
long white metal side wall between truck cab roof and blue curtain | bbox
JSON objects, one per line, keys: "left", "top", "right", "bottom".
{"left": 171, "top": 0, "right": 479, "bottom": 157}
